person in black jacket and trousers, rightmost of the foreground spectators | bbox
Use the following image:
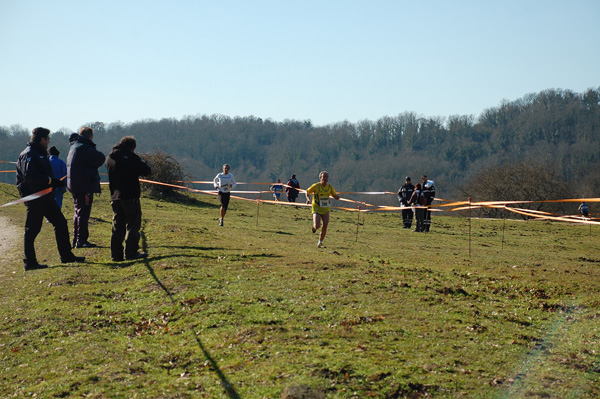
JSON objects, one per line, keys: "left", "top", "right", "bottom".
{"left": 106, "top": 136, "right": 150, "bottom": 262}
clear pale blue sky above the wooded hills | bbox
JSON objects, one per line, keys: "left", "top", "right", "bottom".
{"left": 0, "top": 0, "right": 600, "bottom": 131}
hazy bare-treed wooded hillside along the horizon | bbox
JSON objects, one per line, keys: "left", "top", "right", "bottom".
{"left": 0, "top": 88, "right": 600, "bottom": 205}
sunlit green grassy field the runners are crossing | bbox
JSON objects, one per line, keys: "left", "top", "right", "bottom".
{"left": 0, "top": 185, "right": 600, "bottom": 398}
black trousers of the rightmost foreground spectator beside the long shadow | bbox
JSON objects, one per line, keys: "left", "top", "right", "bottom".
{"left": 110, "top": 198, "right": 142, "bottom": 259}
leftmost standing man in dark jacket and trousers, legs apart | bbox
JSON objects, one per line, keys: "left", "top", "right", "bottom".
{"left": 17, "top": 127, "right": 85, "bottom": 271}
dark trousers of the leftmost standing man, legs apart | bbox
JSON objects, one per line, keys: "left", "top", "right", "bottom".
{"left": 23, "top": 194, "right": 73, "bottom": 266}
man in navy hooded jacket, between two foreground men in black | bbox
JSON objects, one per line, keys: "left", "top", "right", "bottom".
{"left": 67, "top": 127, "right": 105, "bottom": 248}
